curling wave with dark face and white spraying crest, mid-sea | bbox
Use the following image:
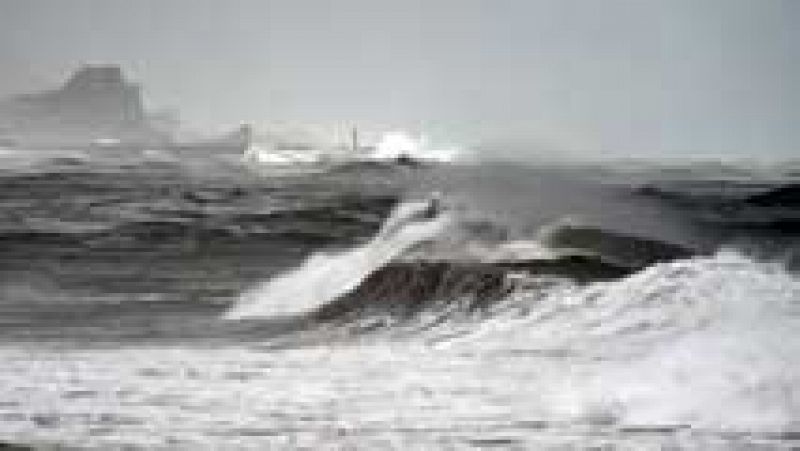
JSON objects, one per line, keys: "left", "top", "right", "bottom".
{"left": 226, "top": 197, "right": 691, "bottom": 321}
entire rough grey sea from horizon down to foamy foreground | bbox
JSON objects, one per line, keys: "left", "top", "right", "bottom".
{"left": 0, "top": 147, "right": 800, "bottom": 449}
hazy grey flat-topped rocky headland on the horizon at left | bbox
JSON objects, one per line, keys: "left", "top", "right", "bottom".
{"left": 0, "top": 66, "right": 169, "bottom": 146}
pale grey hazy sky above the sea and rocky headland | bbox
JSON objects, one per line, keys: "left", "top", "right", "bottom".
{"left": 0, "top": 0, "right": 800, "bottom": 156}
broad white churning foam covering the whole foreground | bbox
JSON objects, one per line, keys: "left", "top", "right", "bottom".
{"left": 0, "top": 247, "right": 800, "bottom": 449}
